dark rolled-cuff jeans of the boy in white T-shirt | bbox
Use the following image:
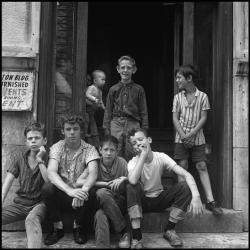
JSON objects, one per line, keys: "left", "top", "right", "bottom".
{"left": 127, "top": 181, "right": 192, "bottom": 223}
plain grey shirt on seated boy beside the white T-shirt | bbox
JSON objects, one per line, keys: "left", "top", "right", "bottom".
{"left": 97, "top": 156, "right": 128, "bottom": 182}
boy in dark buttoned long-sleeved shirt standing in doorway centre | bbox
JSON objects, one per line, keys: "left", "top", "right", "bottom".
{"left": 103, "top": 56, "right": 148, "bottom": 161}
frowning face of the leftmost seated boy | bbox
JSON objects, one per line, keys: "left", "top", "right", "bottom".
{"left": 26, "top": 131, "right": 47, "bottom": 152}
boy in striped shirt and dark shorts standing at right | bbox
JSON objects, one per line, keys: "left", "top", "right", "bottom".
{"left": 172, "top": 65, "right": 223, "bottom": 215}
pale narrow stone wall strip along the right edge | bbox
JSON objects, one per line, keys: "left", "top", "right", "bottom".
{"left": 233, "top": 2, "right": 249, "bottom": 231}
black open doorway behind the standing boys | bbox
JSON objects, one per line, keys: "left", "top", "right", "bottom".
{"left": 87, "top": 2, "right": 175, "bottom": 141}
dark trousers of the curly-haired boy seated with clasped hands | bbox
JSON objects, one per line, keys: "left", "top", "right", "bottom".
{"left": 42, "top": 183, "right": 96, "bottom": 230}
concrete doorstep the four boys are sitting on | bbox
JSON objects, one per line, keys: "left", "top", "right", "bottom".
{"left": 2, "top": 208, "right": 243, "bottom": 233}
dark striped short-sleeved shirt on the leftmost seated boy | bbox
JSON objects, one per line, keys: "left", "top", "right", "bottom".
{"left": 7, "top": 149, "right": 48, "bottom": 205}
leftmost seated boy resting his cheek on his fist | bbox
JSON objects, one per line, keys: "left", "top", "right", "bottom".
{"left": 2, "top": 122, "right": 48, "bottom": 248}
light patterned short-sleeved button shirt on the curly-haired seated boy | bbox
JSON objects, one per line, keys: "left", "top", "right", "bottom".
{"left": 49, "top": 140, "right": 100, "bottom": 187}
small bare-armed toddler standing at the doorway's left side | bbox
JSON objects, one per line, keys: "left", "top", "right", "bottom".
{"left": 85, "top": 70, "right": 106, "bottom": 147}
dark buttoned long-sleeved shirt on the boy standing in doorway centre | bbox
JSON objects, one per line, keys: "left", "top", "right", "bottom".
{"left": 103, "top": 81, "right": 148, "bottom": 129}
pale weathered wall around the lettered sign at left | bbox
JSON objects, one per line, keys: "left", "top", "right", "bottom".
{"left": 2, "top": 2, "right": 40, "bottom": 230}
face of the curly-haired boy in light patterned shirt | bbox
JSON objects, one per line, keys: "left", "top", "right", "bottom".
{"left": 62, "top": 122, "right": 81, "bottom": 144}
